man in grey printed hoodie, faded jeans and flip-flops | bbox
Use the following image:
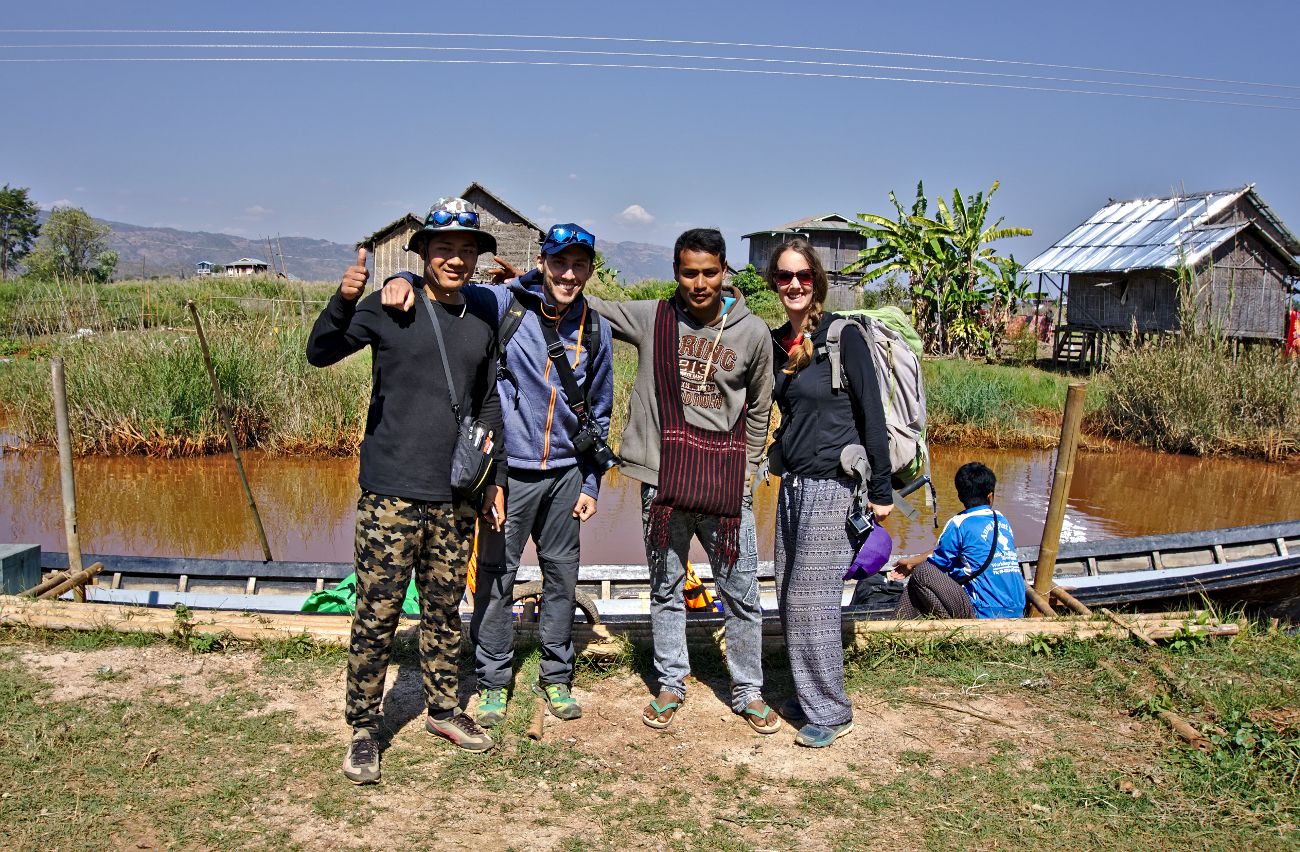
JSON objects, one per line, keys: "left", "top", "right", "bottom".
{"left": 588, "top": 229, "right": 780, "bottom": 734}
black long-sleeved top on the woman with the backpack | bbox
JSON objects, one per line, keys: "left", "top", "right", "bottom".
{"left": 772, "top": 313, "right": 893, "bottom": 506}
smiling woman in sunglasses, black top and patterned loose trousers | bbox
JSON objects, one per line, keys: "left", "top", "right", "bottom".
{"left": 766, "top": 237, "right": 893, "bottom": 748}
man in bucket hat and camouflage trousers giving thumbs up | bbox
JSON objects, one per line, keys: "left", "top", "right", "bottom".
{"left": 307, "top": 198, "right": 506, "bottom": 783}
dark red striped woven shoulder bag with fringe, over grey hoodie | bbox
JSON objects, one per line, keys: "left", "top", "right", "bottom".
{"left": 647, "top": 302, "right": 745, "bottom": 565}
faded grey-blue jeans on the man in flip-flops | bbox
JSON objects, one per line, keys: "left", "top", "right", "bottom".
{"left": 641, "top": 485, "right": 763, "bottom": 713}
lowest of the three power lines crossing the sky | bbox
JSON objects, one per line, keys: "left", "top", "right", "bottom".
{"left": 0, "top": 56, "right": 1300, "bottom": 112}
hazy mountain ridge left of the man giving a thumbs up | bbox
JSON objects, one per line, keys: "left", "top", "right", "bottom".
{"left": 101, "top": 220, "right": 356, "bottom": 281}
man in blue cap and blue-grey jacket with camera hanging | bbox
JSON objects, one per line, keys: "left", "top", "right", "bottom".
{"left": 384, "top": 222, "right": 618, "bottom": 727}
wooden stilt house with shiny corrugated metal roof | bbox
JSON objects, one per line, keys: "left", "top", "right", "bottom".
{"left": 1024, "top": 183, "right": 1300, "bottom": 366}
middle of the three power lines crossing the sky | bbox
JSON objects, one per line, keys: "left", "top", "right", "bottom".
{"left": 10, "top": 43, "right": 1300, "bottom": 100}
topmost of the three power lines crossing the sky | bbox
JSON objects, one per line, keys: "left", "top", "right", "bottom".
{"left": 0, "top": 27, "right": 1300, "bottom": 90}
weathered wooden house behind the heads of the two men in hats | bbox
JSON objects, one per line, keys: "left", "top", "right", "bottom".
{"left": 356, "top": 182, "right": 546, "bottom": 286}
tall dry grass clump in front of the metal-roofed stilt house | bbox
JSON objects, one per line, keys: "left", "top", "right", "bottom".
{"left": 1095, "top": 337, "right": 1300, "bottom": 460}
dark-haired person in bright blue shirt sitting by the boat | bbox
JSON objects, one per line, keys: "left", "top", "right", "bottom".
{"left": 891, "top": 462, "right": 1024, "bottom": 618}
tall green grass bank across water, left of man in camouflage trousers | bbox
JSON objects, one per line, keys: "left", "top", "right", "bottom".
{"left": 0, "top": 323, "right": 371, "bottom": 457}
